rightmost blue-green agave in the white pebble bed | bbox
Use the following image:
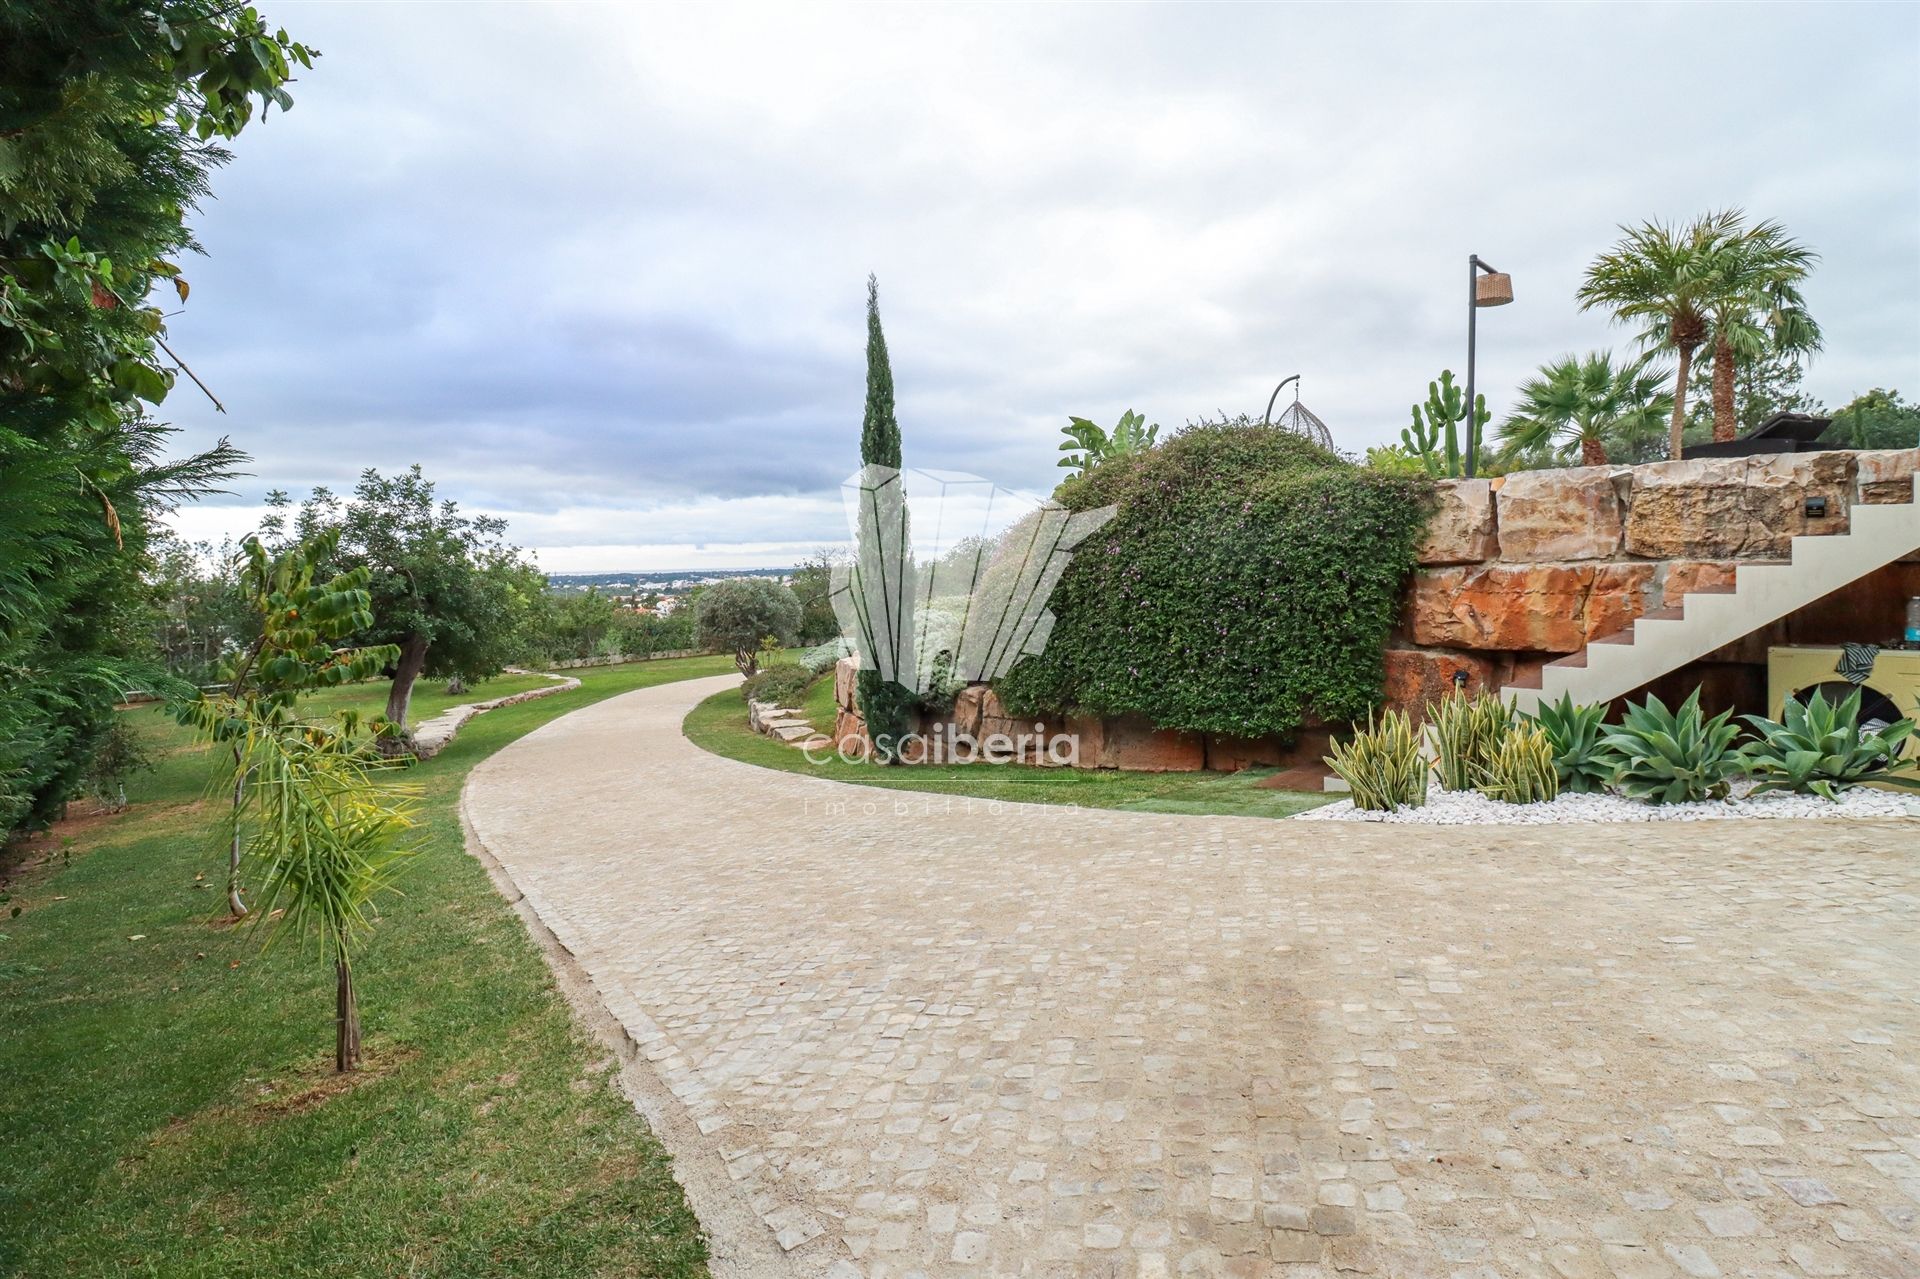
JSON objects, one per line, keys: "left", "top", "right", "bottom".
{"left": 1740, "top": 689, "right": 1920, "bottom": 799}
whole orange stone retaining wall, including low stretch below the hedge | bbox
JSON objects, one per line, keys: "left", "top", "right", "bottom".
{"left": 833, "top": 449, "right": 1920, "bottom": 772}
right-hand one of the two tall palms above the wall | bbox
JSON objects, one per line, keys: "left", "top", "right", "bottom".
{"left": 1707, "top": 209, "right": 1820, "bottom": 440}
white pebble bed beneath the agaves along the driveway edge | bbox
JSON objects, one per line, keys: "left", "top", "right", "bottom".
{"left": 1292, "top": 785, "right": 1920, "bottom": 826}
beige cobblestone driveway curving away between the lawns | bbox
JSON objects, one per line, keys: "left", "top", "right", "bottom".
{"left": 467, "top": 680, "right": 1920, "bottom": 1279}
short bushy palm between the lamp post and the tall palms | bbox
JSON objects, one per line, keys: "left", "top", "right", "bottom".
{"left": 1500, "top": 351, "right": 1672, "bottom": 467}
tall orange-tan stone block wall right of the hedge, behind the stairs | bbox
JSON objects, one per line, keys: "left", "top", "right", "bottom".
{"left": 1386, "top": 449, "right": 1920, "bottom": 711}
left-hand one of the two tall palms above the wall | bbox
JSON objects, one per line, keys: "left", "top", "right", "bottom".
{"left": 1574, "top": 213, "right": 1738, "bottom": 457}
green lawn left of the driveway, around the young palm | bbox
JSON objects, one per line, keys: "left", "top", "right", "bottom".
{"left": 0, "top": 657, "right": 737, "bottom": 1279}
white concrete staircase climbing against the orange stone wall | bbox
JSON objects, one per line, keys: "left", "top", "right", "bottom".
{"left": 1501, "top": 476, "right": 1920, "bottom": 712}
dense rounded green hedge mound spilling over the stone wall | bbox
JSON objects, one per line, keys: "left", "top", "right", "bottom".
{"left": 998, "top": 419, "right": 1434, "bottom": 737}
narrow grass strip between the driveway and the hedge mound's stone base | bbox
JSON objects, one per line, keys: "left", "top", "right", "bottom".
{"left": 685, "top": 676, "right": 1336, "bottom": 818}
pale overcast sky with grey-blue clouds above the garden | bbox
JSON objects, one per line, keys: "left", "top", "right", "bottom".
{"left": 165, "top": 0, "right": 1920, "bottom": 572}
